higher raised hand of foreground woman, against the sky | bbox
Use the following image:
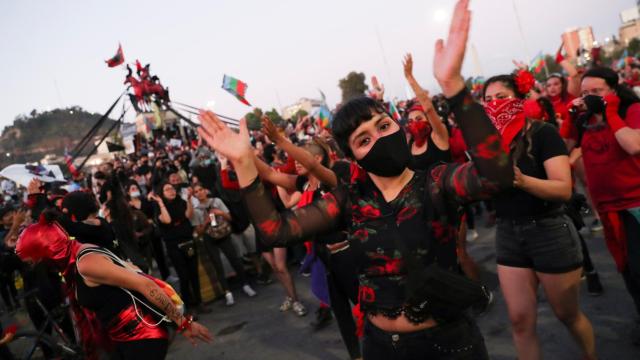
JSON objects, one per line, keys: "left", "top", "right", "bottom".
{"left": 433, "top": 0, "right": 471, "bottom": 97}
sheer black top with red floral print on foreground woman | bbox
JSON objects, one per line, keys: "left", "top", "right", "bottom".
{"left": 243, "top": 90, "right": 513, "bottom": 323}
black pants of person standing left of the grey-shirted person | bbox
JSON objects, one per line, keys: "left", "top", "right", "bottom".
{"left": 167, "top": 241, "right": 202, "bottom": 307}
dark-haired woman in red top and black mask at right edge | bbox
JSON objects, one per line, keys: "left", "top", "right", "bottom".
{"left": 569, "top": 67, "right": 640, "bottom": 345}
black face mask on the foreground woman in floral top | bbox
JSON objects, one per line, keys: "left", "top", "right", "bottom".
{"left": 357, "top": 129, "right": 411, "bottom": 177}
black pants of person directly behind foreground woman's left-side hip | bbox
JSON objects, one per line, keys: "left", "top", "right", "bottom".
{"left": 327, "top": 248, "right": 362, "bottom": 359}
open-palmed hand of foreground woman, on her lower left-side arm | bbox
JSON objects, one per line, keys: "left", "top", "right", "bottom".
{"left": 198, "top": 111, "right": 253, "bottom": 163}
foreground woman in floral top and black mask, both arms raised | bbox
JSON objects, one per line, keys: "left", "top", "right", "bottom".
{"left": 199, "top": 0, "right": 513, "bottom": 360}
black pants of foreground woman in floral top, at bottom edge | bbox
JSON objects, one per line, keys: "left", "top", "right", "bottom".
{"left": 363, "top": 317, "right": 489, "bottom": 360}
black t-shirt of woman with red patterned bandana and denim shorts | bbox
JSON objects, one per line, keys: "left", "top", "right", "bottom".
{"left": 495, "top": 123, "right": 568, "bottom": 219}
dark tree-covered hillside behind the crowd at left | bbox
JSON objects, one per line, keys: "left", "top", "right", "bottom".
{"left": 0, "top": 106, "right": 113, "bottom": 168}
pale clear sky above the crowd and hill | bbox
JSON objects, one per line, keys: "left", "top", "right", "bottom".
{"left": 0, "top": 0, "right": 635, "bottom": 128}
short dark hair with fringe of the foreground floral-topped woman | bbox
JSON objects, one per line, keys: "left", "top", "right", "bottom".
{"left": 331, "top": 96, "right": 388, "bottom": 157}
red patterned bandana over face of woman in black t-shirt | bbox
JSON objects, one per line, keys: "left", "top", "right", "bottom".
{"left": 484, "top": 99, "right": 525, "bottom": 153}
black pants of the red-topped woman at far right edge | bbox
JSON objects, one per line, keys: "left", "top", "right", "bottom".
{"left": 620, "top": 211, "right": 640, "bottom": 315}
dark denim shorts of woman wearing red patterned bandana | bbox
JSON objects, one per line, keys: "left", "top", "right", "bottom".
{"left": 496, "top": 214, "right": 582, "bottom": 274}
